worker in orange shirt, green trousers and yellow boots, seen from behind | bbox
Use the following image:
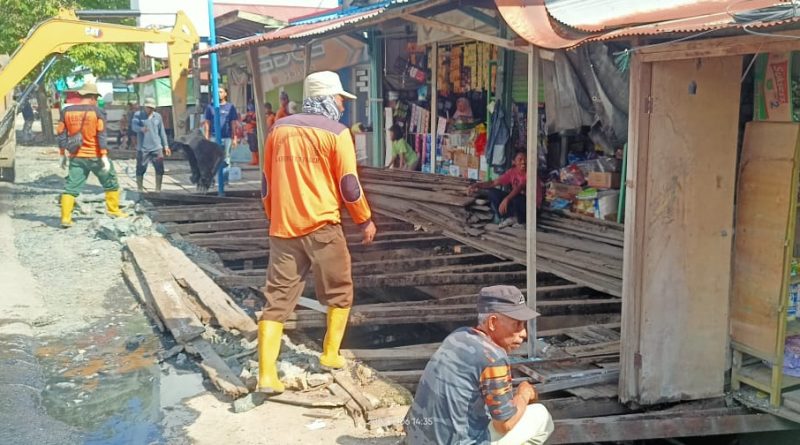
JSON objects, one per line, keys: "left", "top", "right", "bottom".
{"left": 56, "top": 83, "right": 128, "bottom": 228}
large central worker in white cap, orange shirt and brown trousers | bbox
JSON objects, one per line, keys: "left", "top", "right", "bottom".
{"left": 258, "top": 71, "right": 376, "bottom": 393}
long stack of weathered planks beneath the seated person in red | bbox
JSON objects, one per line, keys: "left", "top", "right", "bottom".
{"left": 360, "top": 167, "right": 623, "bottom": 297}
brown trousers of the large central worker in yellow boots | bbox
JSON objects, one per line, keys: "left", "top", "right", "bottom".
{"left": 261, "top": 224, "right": 353, "bottom": 323}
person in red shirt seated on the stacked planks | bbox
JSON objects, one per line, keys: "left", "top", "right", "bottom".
{"left": 467, "top": 151, "right": 542, "bottom": 227}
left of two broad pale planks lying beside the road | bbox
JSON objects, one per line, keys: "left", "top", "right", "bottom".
{"left": 127, "top": 238, "right": 205, "bottom": 343}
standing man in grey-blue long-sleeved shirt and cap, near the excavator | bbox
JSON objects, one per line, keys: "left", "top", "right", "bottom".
{"left": 133, "top": 97, "right": 172, "bottom": 193}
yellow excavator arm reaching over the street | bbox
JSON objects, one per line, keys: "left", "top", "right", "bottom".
{"left": 0, "top": 10, "right": 200, "bottom": 136}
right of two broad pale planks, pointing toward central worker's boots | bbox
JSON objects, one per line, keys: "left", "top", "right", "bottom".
{"left": 149, "top": 237, "right": 258, "bottom": 341}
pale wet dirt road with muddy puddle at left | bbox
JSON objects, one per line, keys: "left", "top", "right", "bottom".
{"left": 0, "top": 137, "right": 398, "bottom": 445}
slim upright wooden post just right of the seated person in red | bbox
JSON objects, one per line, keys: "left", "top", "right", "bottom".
{"left": 528, "top": 45, "right": 539, "bottom": 357}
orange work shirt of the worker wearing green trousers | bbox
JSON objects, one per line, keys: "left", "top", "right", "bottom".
{"left": 56, "top": 104, "right": 108, "bottom": 158}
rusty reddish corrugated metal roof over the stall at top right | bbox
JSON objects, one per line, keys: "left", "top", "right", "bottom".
{"left": 495, "top": 0, "right": 799, "bottom": 49}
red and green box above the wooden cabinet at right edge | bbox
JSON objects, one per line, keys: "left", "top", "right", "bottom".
{"left": 753, "top": 52, "right": 800, "bottom": 122}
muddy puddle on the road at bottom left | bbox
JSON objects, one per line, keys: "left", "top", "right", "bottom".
{"left": 36, "top": 298, "right": 205, "bottom": 444}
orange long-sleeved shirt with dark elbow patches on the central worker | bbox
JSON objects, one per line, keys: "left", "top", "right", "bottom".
{"left": 261, "top": 114, "right": 372, "bottom": 238}
